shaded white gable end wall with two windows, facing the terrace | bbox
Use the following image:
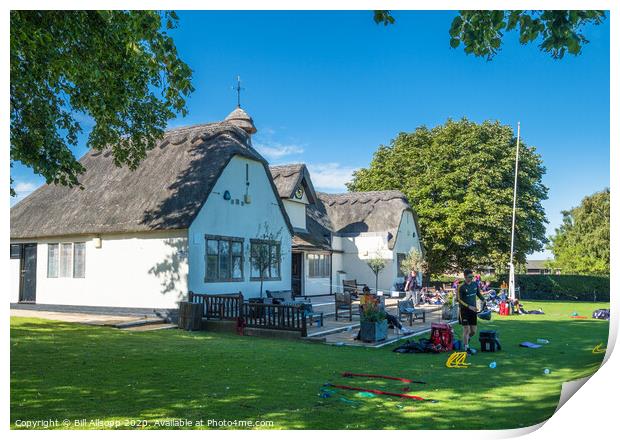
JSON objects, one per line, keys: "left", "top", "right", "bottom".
{"left": 189, "top": 156, "right": 291, "bottom": 298}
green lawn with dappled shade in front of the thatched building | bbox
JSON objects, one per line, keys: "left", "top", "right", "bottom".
{"left": 11, "top": 302, "right": 609, "bottom": 429}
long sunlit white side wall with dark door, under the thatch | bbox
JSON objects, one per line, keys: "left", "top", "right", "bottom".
{"left": 10, "top": 230, "right": 187, "bottom": 309}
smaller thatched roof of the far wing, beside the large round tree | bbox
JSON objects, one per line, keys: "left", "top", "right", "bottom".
{"left": 317, "top": 191, "right": 417, "bottom": 249}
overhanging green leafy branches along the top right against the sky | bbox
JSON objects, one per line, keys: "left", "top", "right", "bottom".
{"left": 374, "top": 10, "right": 606, "bottom": 60}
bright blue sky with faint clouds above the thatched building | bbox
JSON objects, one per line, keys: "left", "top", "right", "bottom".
{"left": 11, "top": 11, "right": 610, "bottom": 257}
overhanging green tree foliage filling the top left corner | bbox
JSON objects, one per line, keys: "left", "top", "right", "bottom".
{"left": 10, "top": 11, "right": 193, "bottom": 192}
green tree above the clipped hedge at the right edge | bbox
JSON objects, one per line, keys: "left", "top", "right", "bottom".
{"left": 548, "top": 189, "right": 610, "bottom": 275}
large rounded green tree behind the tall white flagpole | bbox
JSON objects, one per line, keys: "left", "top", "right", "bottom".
{"left": 347, "top": 119, "right": 547, "bottom": 275}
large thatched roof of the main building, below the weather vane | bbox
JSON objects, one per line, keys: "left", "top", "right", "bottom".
{"left": 11, "top": 122, "right": 292, "bottom": 238}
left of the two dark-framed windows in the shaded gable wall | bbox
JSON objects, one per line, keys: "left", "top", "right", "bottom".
{"left": 205, "top": 235, "right": 243, "bottom": 282}
